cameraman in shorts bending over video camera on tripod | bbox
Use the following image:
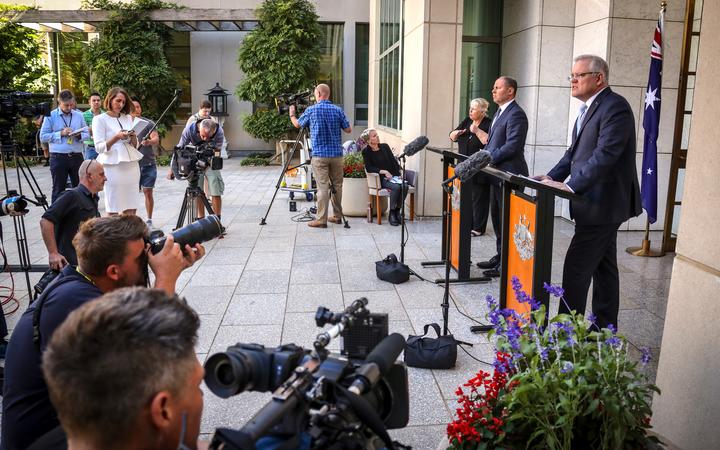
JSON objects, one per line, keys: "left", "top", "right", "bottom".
{"left": 168, "top": 118, "right": 225, "bottom": 229}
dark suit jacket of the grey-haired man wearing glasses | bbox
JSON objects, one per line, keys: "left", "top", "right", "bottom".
{"left": 548, "top": 87, "right": 642, "bottom": 225}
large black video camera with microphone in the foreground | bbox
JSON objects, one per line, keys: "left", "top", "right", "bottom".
{"left": 205, "top": 298, "right": 409, "bottom": 450}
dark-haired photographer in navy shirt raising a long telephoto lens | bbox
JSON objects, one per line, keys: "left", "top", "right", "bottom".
{"left": 0, "top": 215, "right": 205, "bottom": 450}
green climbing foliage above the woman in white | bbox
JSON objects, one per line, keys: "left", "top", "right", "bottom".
{"left": 84, "top": 0, "right": 178, "bottom": 134}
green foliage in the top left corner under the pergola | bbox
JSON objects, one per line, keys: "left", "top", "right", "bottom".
{"left": 0, "top": 4, "right": 53, "bottom": 92}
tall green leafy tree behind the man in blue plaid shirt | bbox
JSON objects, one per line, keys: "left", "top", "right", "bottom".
{"left": 235, "top": 0, "right": 321, "bottom": 141}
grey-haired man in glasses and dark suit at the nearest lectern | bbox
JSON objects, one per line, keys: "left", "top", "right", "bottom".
{"left": 534, "top": 55, "right": 642, "bottom": 328}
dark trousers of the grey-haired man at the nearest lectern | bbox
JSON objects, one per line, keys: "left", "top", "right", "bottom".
{"left": 558, "top": 223, "right": 620, "bottom": 328}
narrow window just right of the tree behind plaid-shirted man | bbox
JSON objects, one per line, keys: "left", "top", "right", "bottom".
{"left": 318, "top": 23, "right": 344, "bottom": 107}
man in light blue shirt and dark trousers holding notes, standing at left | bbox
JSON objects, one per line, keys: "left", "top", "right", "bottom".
{"left": 40, "top": 89, "right": 90, "bottom": 202}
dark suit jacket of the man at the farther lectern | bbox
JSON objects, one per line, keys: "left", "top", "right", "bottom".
{"left": 485, "top": 101, "right": 528, "bottom": 184}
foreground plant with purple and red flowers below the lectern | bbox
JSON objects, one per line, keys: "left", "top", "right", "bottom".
{"left": 447, "top": 277, "right": 660, "bottom": 449}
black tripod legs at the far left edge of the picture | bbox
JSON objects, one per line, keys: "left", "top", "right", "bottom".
{"left": 0, "top": 126, "right": 48, "bottom": 299}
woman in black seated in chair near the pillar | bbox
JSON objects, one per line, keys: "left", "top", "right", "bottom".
{"left": 360, "top": 128, "right": 407, "bottom": 226}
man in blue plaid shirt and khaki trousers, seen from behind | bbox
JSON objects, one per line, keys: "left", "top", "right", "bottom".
{"left": 289, "top": 84, "right": 352, "bottom": 228}
